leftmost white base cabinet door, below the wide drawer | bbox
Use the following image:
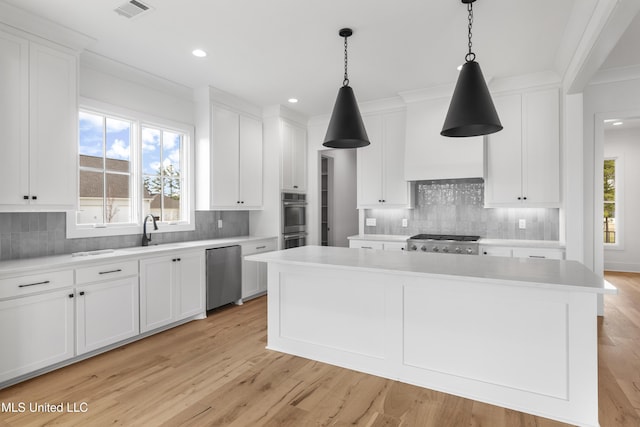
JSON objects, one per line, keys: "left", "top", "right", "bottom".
{"left": 0, "top": 288, "right": 74, "bottom": 382}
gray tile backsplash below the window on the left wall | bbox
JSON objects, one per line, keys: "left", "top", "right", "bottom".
{"left": 0, "top": 211, "right": 249, "bottom": 261}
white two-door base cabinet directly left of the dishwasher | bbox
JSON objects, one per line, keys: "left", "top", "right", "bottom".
{"left": 140, "top": 251, "right": 206, "bottom": 332}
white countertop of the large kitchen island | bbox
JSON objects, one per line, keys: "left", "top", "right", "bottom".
{"left": 245, "top": 246, "right": 617, "bottom": 294}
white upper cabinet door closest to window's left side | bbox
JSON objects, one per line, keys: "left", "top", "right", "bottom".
{"left": 29, "top": 43, "right": 78, "bottom": 210}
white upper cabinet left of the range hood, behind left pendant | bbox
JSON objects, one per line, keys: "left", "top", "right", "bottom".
{"left": 357, "top": 111, "right": 413, "bottom": 209}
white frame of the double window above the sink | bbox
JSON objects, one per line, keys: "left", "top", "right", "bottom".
{"left": 66, "top": 98, "right": 195, "bottom": 238}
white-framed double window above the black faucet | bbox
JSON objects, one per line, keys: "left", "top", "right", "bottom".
{"left": 67, "top": 103, "right": 195, "bottom": 237}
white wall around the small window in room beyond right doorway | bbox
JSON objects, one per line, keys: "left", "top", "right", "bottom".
{"left": 604, "top": 128, "right": 640, "bottom": 272}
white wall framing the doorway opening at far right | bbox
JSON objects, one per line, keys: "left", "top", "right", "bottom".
{"left": 583, "top": 79, "right": 640, "bottom": 274}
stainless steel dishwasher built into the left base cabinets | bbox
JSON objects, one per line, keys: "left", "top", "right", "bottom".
{"left": 206, "top": 245, "right": 242, "bottom": 310}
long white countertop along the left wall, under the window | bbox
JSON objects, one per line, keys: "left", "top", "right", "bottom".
{"left": 0, "top": 236, "right": 276, "bottom": 277}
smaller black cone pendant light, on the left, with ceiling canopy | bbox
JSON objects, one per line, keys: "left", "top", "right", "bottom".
{"left": 322, "top": 28, "right": 370, "bottom": 148}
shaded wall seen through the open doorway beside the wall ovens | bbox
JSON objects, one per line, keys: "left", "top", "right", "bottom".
{"left": 322, "top": 149, "right": 358, "bottom": 247}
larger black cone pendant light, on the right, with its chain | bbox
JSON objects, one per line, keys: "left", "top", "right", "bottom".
{"left": 440, "top": 0, "right": 502, "bottom": 137}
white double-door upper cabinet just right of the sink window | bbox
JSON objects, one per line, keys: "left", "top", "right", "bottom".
{"left": 195, "top": 87, "right": 263, "bottom": 210}
